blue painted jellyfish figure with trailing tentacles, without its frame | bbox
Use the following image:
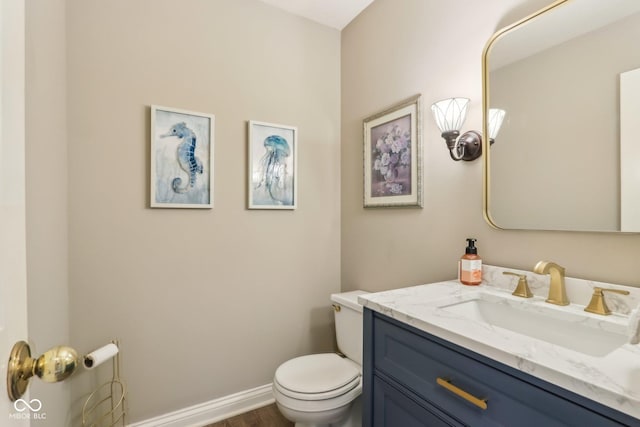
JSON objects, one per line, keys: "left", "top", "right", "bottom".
{"left": 255, "top": 135, "right": 291, "bottom": 205}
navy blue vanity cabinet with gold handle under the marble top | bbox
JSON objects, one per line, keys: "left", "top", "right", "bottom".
{"left": 363, "top": 308, "right": 640, "bottom": 427}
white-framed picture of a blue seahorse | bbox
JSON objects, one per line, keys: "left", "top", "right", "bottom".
{"left": 151, "top": 105, "right": 215, "bottom": 209}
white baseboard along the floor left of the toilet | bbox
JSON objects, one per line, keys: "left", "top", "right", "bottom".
{"left": 128, "top": 384, "right": 275, "bottom": 427}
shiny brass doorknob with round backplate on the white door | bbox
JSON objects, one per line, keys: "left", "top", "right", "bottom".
{"left": 7, "top": 341, "right": 79, "bottom": 402}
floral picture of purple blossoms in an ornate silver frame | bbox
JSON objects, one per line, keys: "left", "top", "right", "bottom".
{"left": 364, "top": 95, "right": 422, "bottom": 208}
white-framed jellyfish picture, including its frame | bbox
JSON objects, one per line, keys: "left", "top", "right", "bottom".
{"left": 247, "top": 120, "right": 298, "bottom": 209}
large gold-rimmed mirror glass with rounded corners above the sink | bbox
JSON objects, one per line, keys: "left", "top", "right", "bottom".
{"left": 483, "top": 0, "right": 640, "bottom": 232}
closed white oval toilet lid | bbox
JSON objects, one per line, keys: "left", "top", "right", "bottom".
{"left": 275, "top": 353, "right": 360, "bottom": 394}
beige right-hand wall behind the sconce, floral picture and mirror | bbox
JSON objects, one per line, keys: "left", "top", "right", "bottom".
{"left": 341, "top": 0, "right": 640, "bottom": 291}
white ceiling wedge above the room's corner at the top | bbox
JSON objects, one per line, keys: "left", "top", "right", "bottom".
{"left": 261, "top": 0, "right": 373, "bottom": 30}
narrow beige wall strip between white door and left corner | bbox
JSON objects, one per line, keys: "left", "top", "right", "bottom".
{"left": 25, "top": 0, "right": 71, "bottom": 426}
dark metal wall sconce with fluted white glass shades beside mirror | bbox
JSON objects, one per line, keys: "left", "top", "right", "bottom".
{"left": 431, "top": 98, "right": 505, "bottom": 161}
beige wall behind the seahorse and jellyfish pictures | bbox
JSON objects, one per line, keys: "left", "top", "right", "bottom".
{"left": 67, "top": 0, "right": 340, "bottom": 421}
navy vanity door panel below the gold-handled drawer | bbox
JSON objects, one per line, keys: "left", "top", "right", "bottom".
{"left": 373, "top": 377, "right": 463, "bottom": 427}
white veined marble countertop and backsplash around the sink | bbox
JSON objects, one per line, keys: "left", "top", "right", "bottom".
{"left": 358, "top": 266, "right": 640, "bottom": 419}
